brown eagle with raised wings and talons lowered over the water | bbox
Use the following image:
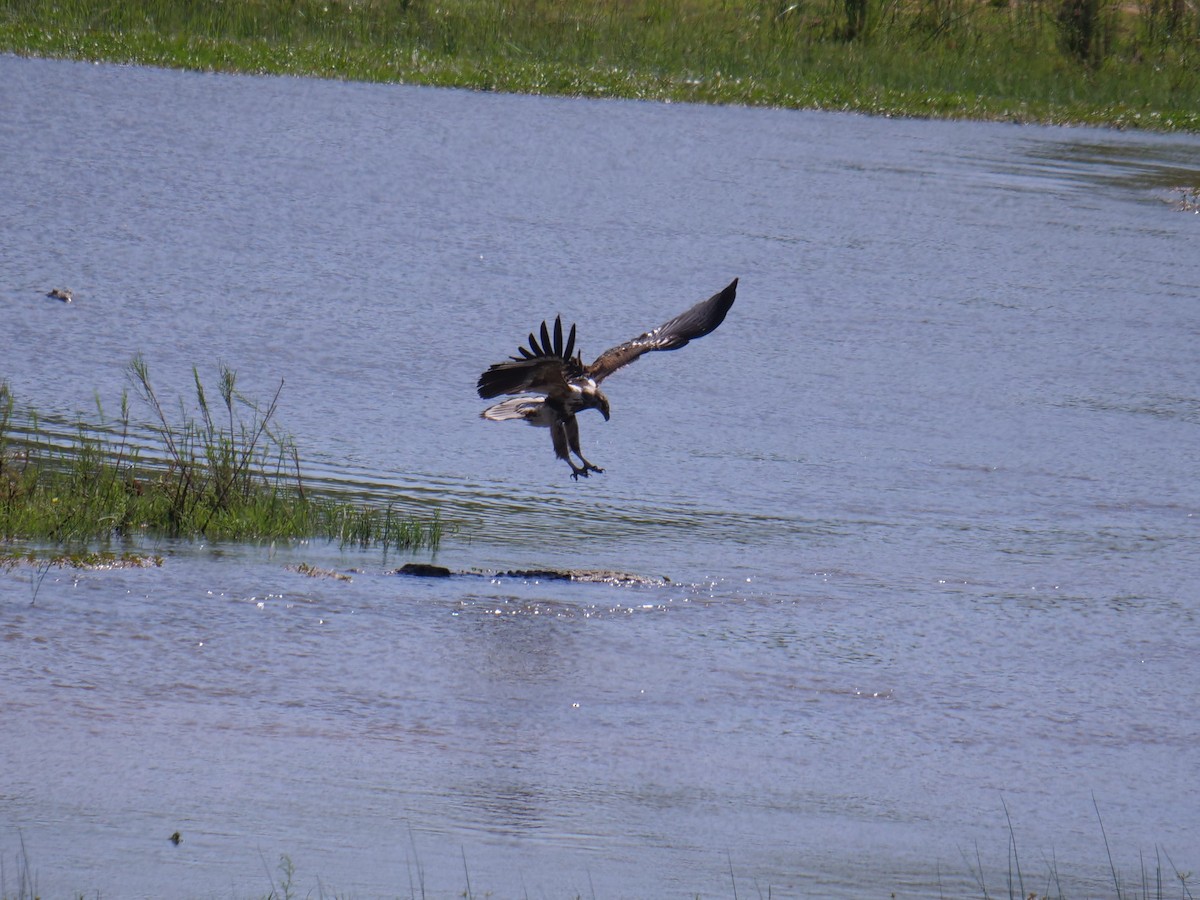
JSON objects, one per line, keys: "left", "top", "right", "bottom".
{"left": 476, "top": 278, "right": 738, "bottom": 480}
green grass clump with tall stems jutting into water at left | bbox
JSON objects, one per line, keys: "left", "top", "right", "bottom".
{"left": 0, "top": 359, "right": 443, "bottom": 549}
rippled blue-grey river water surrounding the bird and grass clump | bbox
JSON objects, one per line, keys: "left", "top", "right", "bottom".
{"left": 0, "top": 58, "right": 1200, "bottom": 900}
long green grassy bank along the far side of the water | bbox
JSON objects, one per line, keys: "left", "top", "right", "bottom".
{"left": 0, "top": 0, "right": 1200, "bottom": 131}
